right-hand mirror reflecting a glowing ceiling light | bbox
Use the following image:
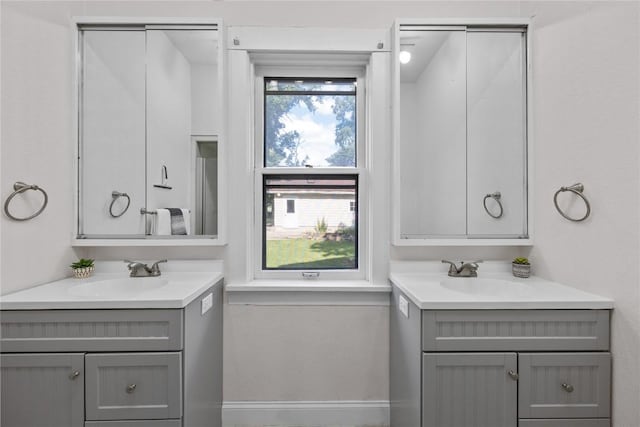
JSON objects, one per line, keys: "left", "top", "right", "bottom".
{"left": 396, "top": 25, "right": 528, "bottom": 240}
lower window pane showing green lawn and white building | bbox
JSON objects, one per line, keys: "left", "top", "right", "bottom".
{"left": 262, "top": 175, "right": 358, "bottom": 270}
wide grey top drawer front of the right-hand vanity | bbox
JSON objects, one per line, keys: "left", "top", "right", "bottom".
{"left": 422, "top": 310, "right": 609, "bottom": 352}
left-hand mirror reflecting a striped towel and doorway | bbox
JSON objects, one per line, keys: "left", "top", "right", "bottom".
{"left": 78, "top": 25, "right": 222, "bottom": 239}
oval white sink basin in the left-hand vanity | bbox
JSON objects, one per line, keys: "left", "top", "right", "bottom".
{"left": 68, "top": 277, "right": 169, "bottom": 298}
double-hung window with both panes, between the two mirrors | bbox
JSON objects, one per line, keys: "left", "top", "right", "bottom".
{"left": 256, "top": 73, "right": 363, "bottom": 274}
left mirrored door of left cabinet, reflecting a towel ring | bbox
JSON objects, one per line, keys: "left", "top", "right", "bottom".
{"left": 79, "top": 28, "right": 146, "bottom": 236}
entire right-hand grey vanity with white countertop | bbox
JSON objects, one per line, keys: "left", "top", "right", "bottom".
{"left": 390, "top": 264, "right": 613, "bottom": 427}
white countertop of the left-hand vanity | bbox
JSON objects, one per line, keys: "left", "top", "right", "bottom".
{"left": 0, "top": 261, "right": 223, "bottom": 310}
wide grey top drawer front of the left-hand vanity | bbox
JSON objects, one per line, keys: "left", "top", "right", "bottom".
{"left": 0, "top": 310, "right": 183, "bottom": 353}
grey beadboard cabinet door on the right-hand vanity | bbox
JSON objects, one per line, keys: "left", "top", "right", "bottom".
{"left": 422, "top": 353, "right": 518, "bottom": 427}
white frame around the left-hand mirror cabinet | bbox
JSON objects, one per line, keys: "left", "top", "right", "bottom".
{"left": 70, "top": 17, "right": 228, "bottom": 247}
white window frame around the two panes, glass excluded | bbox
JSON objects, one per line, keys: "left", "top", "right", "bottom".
{"left": 253, "top": 61, "right": 370, "bottom": 280}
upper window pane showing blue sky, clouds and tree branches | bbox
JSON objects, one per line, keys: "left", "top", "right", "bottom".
{"left": 264, "top": 78, "right": 356, "bottom": 167}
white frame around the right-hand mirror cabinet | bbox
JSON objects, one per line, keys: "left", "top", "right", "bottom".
{"left": 391, "top": 18, "right": 534, "bottom": 247}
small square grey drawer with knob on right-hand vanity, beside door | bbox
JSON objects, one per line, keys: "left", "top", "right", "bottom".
{"left": 518, "top": 353, "right": 611, "bottom": 418}
